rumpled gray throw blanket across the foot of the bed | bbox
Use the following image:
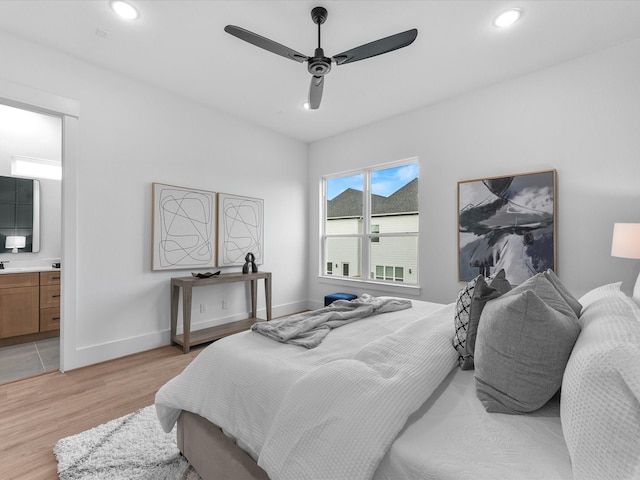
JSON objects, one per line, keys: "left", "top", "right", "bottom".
{"left": 251, "top": 294, "right": 411, "bottom": 348}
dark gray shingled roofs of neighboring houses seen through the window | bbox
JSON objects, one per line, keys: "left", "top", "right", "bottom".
{"left": 327, "top": 178, "right": 418, "bottom": 218}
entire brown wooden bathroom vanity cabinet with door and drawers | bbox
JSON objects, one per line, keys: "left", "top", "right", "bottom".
{"left": 0, "top": 271, "right": 60, "bottom": 339}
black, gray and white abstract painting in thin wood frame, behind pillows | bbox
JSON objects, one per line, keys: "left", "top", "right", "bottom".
{"left": 458, "top": 170, "right": 556, "bottom": 285}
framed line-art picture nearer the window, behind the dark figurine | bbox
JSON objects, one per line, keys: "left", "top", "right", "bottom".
{"left": 218, "top": 193, "right": 264, "bottom": 267}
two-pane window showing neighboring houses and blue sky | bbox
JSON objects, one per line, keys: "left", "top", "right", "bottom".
{"left": 321, "top": 159, "right": 419, "bottom": 284}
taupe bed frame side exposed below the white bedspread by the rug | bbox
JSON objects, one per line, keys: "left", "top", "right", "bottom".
{"left": 177, "top": 411, "right": 269, "bottom": 480}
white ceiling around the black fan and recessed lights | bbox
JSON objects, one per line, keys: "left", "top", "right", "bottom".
{"left": 0, "top": 0, "right": 640, "bottom": 142}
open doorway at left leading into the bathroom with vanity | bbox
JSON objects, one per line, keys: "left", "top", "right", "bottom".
{"left": 0, "top": 99, "right": 63, "bottom": 384}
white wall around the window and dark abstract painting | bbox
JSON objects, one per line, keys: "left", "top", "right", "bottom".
{"left": 309, "top": 41, "right": 640, "bottom": 303}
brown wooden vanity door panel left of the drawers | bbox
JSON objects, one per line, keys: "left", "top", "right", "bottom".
{"left": 0, "top": 272, "right": 40, "bottom": 338}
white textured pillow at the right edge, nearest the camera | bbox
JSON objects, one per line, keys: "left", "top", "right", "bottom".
{"left": 560, "top": 283, "right": 640, "bottom": 480}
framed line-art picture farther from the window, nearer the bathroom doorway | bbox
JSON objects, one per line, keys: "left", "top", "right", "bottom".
{"left": 152, "top": 183, "right": 216, "bottom": 270}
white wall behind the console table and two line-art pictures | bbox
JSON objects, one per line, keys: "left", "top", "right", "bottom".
{"left": 0, "top": 28, "right": 308, "bottom": 369}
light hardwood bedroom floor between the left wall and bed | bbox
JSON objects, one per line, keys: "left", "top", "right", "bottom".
{"left": 0, "top": 346, "right": 203, "bottom": 480}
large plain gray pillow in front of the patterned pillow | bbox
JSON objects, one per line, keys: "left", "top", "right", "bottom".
{"left": 474, "top": 274, "right": 580, "bottom": 414}
